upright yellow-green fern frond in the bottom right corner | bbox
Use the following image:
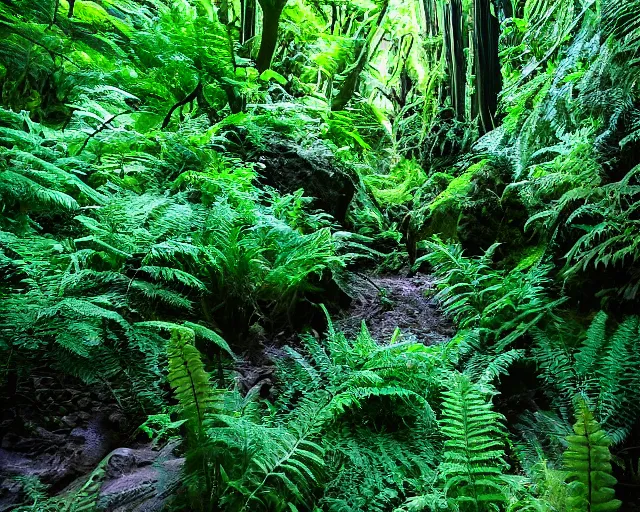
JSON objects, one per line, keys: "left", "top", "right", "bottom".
{"left": 564, "top": 401, "right": 622, "bottom": 512}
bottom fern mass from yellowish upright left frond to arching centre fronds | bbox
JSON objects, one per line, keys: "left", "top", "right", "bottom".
{"left": 168, "top": 316, "right": 450, "bottom": 511}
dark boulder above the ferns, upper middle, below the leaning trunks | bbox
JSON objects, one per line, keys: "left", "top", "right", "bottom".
{"left": 257, "top": 140, "right": 355, "bottom": 224}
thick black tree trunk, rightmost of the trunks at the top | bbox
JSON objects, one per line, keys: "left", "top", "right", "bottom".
{"left": 473, "top": 0, "right": 502, "bottom": 134}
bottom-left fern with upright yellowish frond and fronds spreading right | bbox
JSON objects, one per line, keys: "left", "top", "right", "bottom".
{"left": 163, "top": 325, "right": 326, "bottom": 510}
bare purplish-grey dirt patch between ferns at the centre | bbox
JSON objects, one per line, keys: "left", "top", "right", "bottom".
{"left": 336, "top": 274, "right": 453, "bottom": 345}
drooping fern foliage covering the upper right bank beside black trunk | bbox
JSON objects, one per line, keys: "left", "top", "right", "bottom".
{"left": 478, "top": 1, "right": 638, "bottom": 300}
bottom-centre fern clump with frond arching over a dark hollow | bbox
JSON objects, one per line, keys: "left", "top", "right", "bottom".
{"left": 278, "top": 314, "right": 442, "bottom": 512}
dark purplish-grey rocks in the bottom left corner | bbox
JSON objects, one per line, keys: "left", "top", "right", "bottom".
{"left": 0, "top": 370, "right": 183, "bottom": 512}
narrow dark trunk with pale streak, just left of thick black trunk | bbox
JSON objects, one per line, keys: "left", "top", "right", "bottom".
{"left": 444, "top": 0, "right": 466, "bottom": 121}
